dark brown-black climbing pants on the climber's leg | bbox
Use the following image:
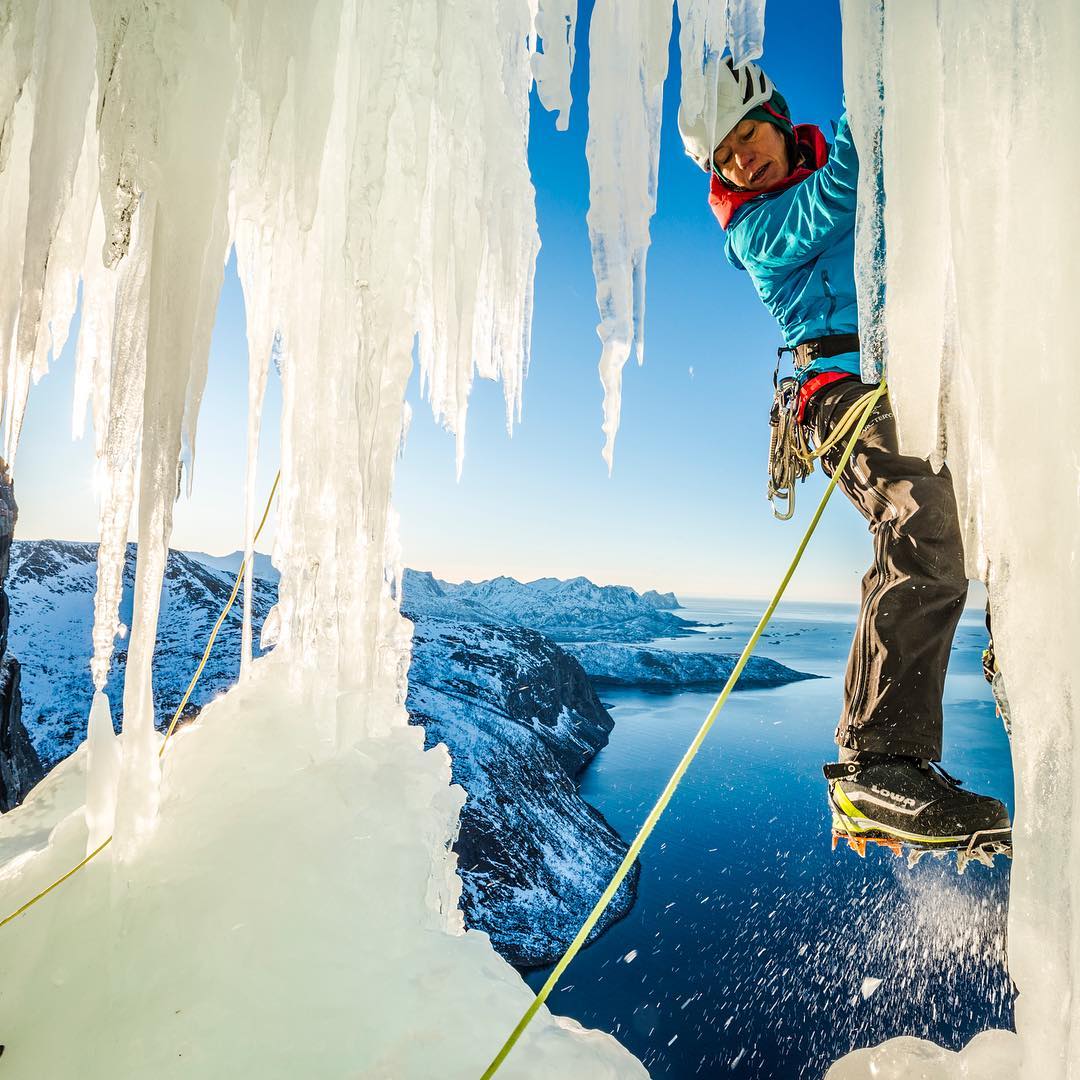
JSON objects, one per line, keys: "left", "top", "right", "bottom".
{"left": 804, "top": 378, "right": 968, "bottom": 760}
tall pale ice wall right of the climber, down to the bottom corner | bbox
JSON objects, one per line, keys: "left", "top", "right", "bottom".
{"left": 829, "top": 0, "right": 1080, "bottom": 1080}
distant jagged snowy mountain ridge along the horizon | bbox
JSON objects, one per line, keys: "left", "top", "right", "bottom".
{"left": 402, "top": 570, "right": 693, "bottom": 642}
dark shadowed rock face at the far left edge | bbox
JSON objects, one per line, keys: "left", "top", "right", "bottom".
{"left": 0, "top": 465, "right": 45, "bottom": 812}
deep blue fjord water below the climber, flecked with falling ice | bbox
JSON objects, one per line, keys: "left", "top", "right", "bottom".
{"left": 527, "top": 600, "right": 1012, "bottom": 1080}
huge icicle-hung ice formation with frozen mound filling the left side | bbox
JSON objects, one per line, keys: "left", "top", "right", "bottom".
{"left": 0, "top": 0, "right": 761, "bottom": 1080}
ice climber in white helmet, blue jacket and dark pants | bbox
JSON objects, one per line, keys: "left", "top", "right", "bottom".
{"left": 679, "top": 59, "right": 1011, "bottom": 861}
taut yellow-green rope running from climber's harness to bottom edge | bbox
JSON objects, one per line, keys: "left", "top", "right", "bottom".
{"left": 481, "top": 379, "right": 886, "bottom": 1080}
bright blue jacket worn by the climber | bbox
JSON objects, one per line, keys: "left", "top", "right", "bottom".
{"left": 725, "top": 113, "right": 859, "bottom": 380}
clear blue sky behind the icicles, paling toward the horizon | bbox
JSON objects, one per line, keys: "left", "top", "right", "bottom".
{"left": 16, "top": 0, "right": 898, "bottom": 599}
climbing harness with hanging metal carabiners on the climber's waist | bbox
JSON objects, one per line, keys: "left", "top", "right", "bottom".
{"left": 768, "top": 347, "right": 877, "bottom": 522}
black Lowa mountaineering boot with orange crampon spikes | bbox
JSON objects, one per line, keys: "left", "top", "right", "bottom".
{"left": 824, "top": 752, "right": 1012, "bottom": 870}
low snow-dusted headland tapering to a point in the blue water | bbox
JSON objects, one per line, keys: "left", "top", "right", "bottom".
{"left": 564, "top": 642, "right": 818, "bottom": 691}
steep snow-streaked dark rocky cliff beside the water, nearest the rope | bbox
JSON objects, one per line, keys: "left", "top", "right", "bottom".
{"left": 406, "top": 618, "right": 637, "bottom": 967}
